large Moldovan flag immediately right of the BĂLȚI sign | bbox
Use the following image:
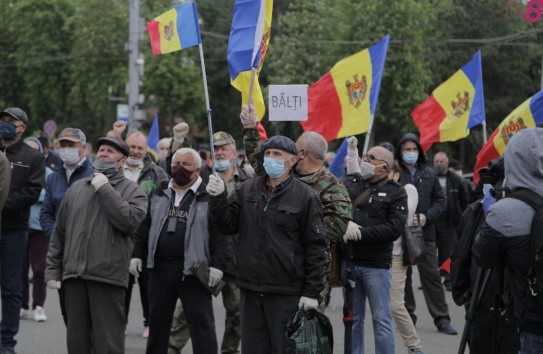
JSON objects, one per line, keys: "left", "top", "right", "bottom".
{"left": 301, "top": 35, "right": 390, "bottom": 141}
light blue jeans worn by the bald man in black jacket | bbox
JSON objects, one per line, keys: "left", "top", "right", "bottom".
{"left": 352, "top": 267, "right": 394, "bottom": 354}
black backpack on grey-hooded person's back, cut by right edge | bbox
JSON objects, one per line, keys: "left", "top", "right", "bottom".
{"left": 508, "top": 188, "right": 543, "bottom": 319}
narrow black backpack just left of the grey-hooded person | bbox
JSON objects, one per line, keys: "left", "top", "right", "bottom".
{"left": 451, "top": 200, "right": 485, "bottom": 306}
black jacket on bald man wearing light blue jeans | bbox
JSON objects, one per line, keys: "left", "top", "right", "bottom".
{"left": 342, "top": 174, "right": 407, "bottom": 268}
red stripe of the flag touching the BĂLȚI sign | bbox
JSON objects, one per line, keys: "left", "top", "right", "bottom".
{"left": 301, "top": 72, "right": 343, "bottom": 141}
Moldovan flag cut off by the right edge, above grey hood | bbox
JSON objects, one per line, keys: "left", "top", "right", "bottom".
{"left": 473, "top": 90, "right": 543, "bottom": 183}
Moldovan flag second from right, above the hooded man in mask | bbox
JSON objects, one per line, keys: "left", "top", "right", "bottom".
{"left": 411, "top": 51, "right": 485, "bottom": 151}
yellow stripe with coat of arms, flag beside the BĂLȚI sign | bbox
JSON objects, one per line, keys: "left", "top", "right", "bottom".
{"left": 332, "top": 49, "right": 372, "bottom": 137}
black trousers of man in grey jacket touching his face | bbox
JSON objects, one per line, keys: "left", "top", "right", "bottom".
{"left": 62, "top": 278, "right": 126, "bottom": 354}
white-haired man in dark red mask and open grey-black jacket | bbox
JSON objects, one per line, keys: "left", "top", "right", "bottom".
{"left": 132, "top": 148, "right": 225, "bottom": 354}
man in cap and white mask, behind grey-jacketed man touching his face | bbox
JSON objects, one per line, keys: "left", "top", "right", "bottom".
{"left": 40, "top": 128, "right": 94, "bottom": 324}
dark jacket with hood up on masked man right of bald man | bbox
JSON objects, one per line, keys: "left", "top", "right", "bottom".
{"left": 396, "top": 133, "right": 446, "bottom": 240}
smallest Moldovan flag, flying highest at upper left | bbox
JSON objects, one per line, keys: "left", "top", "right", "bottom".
{"left": 147, "top": 2, "right": 202, "bottom": 55}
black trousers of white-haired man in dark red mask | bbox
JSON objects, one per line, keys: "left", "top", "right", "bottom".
{"left": 146, "top": 260, "right": 218, "bottom": 354}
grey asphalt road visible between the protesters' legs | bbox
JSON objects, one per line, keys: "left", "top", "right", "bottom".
{"left": 16, "top": 271, "right": 465, "bottom": 354}
